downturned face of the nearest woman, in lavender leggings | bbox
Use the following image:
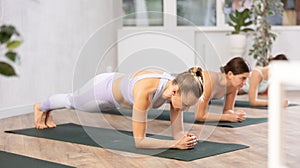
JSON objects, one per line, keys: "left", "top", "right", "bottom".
{"left": 171, "top": 92, "right": 198, "bottom": 111}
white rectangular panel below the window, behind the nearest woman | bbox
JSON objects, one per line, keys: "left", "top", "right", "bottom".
{"left": 118, "top": 29, "right": 195, "bottom": 73}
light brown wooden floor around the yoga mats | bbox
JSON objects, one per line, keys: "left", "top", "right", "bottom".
{"left": 0, "top": 91, "right": 300, "bottom": 168}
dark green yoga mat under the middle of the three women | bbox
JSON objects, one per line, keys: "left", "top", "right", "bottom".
{"left": 102, "top": 109, "right": 268, "bottom": 128}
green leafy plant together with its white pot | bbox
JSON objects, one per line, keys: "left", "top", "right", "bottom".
{"left": 228, "top": 8, "right": 253, "bottom": 56}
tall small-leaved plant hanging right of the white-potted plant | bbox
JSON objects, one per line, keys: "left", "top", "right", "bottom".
{"left": 249, "top": 0, "right": 284, "bottom": 66}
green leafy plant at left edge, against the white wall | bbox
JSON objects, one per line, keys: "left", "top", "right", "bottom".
{"left": 0, "top": 25, "right": 22, "bottom": 76}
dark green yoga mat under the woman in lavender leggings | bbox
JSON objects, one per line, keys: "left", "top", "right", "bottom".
{"left": 5, "top": 123, "right": 249, "bottom": 161}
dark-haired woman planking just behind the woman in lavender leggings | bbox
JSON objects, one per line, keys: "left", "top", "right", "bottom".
{"left": 195, "top": 57, "right": 250, "bottom": 122}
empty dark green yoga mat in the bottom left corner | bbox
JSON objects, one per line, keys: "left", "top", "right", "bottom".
{"left": 0, "top": 151, "right": 71, "bottom": 168}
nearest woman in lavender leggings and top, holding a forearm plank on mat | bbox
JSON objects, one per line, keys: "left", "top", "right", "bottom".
{"left": 34, "top": 68, "right": 203, "bottom": 149}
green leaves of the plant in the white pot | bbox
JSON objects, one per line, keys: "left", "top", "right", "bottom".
{"left": 228, "top": 9, "right": 253, "bottom": 34}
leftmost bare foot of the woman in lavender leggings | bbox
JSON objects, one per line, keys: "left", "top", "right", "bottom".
{"left": 33, "top": 103, "right": 48, "bottom": 129}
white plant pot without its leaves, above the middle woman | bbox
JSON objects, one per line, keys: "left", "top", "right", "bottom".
{"left": 229, "top": 34, "right": 247, "bottom": 57}
